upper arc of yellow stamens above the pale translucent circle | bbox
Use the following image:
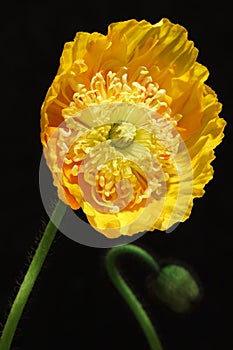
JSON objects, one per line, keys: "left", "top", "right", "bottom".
{"left": 63, "top": 66, "right": 180, "bottom": 125}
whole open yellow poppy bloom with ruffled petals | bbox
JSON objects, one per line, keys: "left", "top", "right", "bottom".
{"left": 41, "top": 19, "right": 225, "bottom": 238}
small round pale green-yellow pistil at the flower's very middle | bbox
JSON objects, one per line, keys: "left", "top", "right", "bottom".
{"left": 109, "top": 122, "right": 137, "bottom": 148}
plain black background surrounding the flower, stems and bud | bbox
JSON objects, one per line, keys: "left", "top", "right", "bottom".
{"left": 0, "top": 0, "right": 233, "bottom": 350}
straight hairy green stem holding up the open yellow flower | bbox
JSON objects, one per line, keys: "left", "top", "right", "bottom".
{"left": 0, "top": 201, "right": 67, "bottom": 350}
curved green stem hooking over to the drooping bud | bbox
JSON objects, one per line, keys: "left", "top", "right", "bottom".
{"left": 106, "top": 245, "right": 162, "bottom": 350}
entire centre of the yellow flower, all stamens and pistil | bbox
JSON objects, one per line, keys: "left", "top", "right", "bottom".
{"left": 59, "top": 63, "right": 186, "bottom": 219}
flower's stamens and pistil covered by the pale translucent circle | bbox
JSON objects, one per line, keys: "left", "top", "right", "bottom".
{"left": 58, "top": 102, "right": 179, "bottom": 213}
